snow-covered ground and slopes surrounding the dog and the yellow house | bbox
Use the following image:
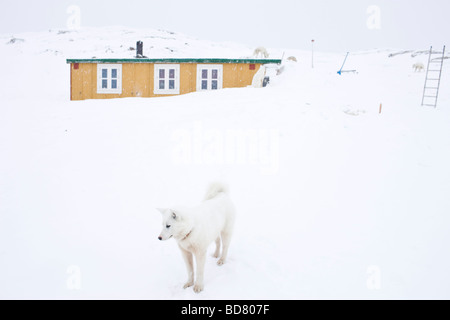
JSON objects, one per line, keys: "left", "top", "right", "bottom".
{"left": 0, "top": 27, "right": 450, "bottom": 299}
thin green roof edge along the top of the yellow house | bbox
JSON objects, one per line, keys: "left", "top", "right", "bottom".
{"left": 67, "top": 58, "right": 281, "bottom": 64}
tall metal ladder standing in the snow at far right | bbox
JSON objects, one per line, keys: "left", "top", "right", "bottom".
{"left": 422, "top": 46, "right": 445, "bottom": 108}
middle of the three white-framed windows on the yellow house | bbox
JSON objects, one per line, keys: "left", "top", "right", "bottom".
{"left": 154, "top": 64, "right": 180, "bottom": 94}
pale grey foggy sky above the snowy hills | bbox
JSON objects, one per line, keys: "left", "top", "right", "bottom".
{"left": 0, "top": 0, "right": 450, "bottom": 52}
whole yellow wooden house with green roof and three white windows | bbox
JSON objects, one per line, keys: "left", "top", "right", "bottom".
{"left": 67, "top": 58, "right": 281, "bottom": 100}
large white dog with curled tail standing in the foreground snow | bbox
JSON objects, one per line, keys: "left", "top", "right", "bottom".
{"left": 158, "top": 183, "right": 235, "bottom": 293}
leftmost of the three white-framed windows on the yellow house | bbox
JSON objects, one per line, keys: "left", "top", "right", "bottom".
{"left": 97, "top": 64, "right": 122, "bottom": 94}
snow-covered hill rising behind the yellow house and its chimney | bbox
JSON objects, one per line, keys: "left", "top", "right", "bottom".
{"left": 0, "top": 27, "right": 252, "bottom": 58}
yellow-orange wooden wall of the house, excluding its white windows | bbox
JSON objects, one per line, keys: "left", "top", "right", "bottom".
{"left": 70, "top": 63, "right": 261, "bottom": 100}
